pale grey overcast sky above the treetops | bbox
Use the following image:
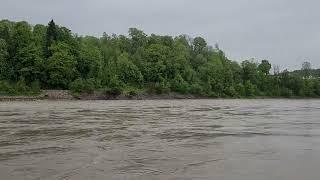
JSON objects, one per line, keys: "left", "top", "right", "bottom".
{"left": 0, "top": 0, "right": 320, "bottom": 69}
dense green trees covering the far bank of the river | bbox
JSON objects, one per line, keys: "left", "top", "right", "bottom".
{"left": 0, "top": 20, "right": 320, "bottom": 98}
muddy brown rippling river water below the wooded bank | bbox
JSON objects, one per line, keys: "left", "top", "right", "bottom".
{"left": 0, "top": 100, "right": 320, "bottom": 180}
